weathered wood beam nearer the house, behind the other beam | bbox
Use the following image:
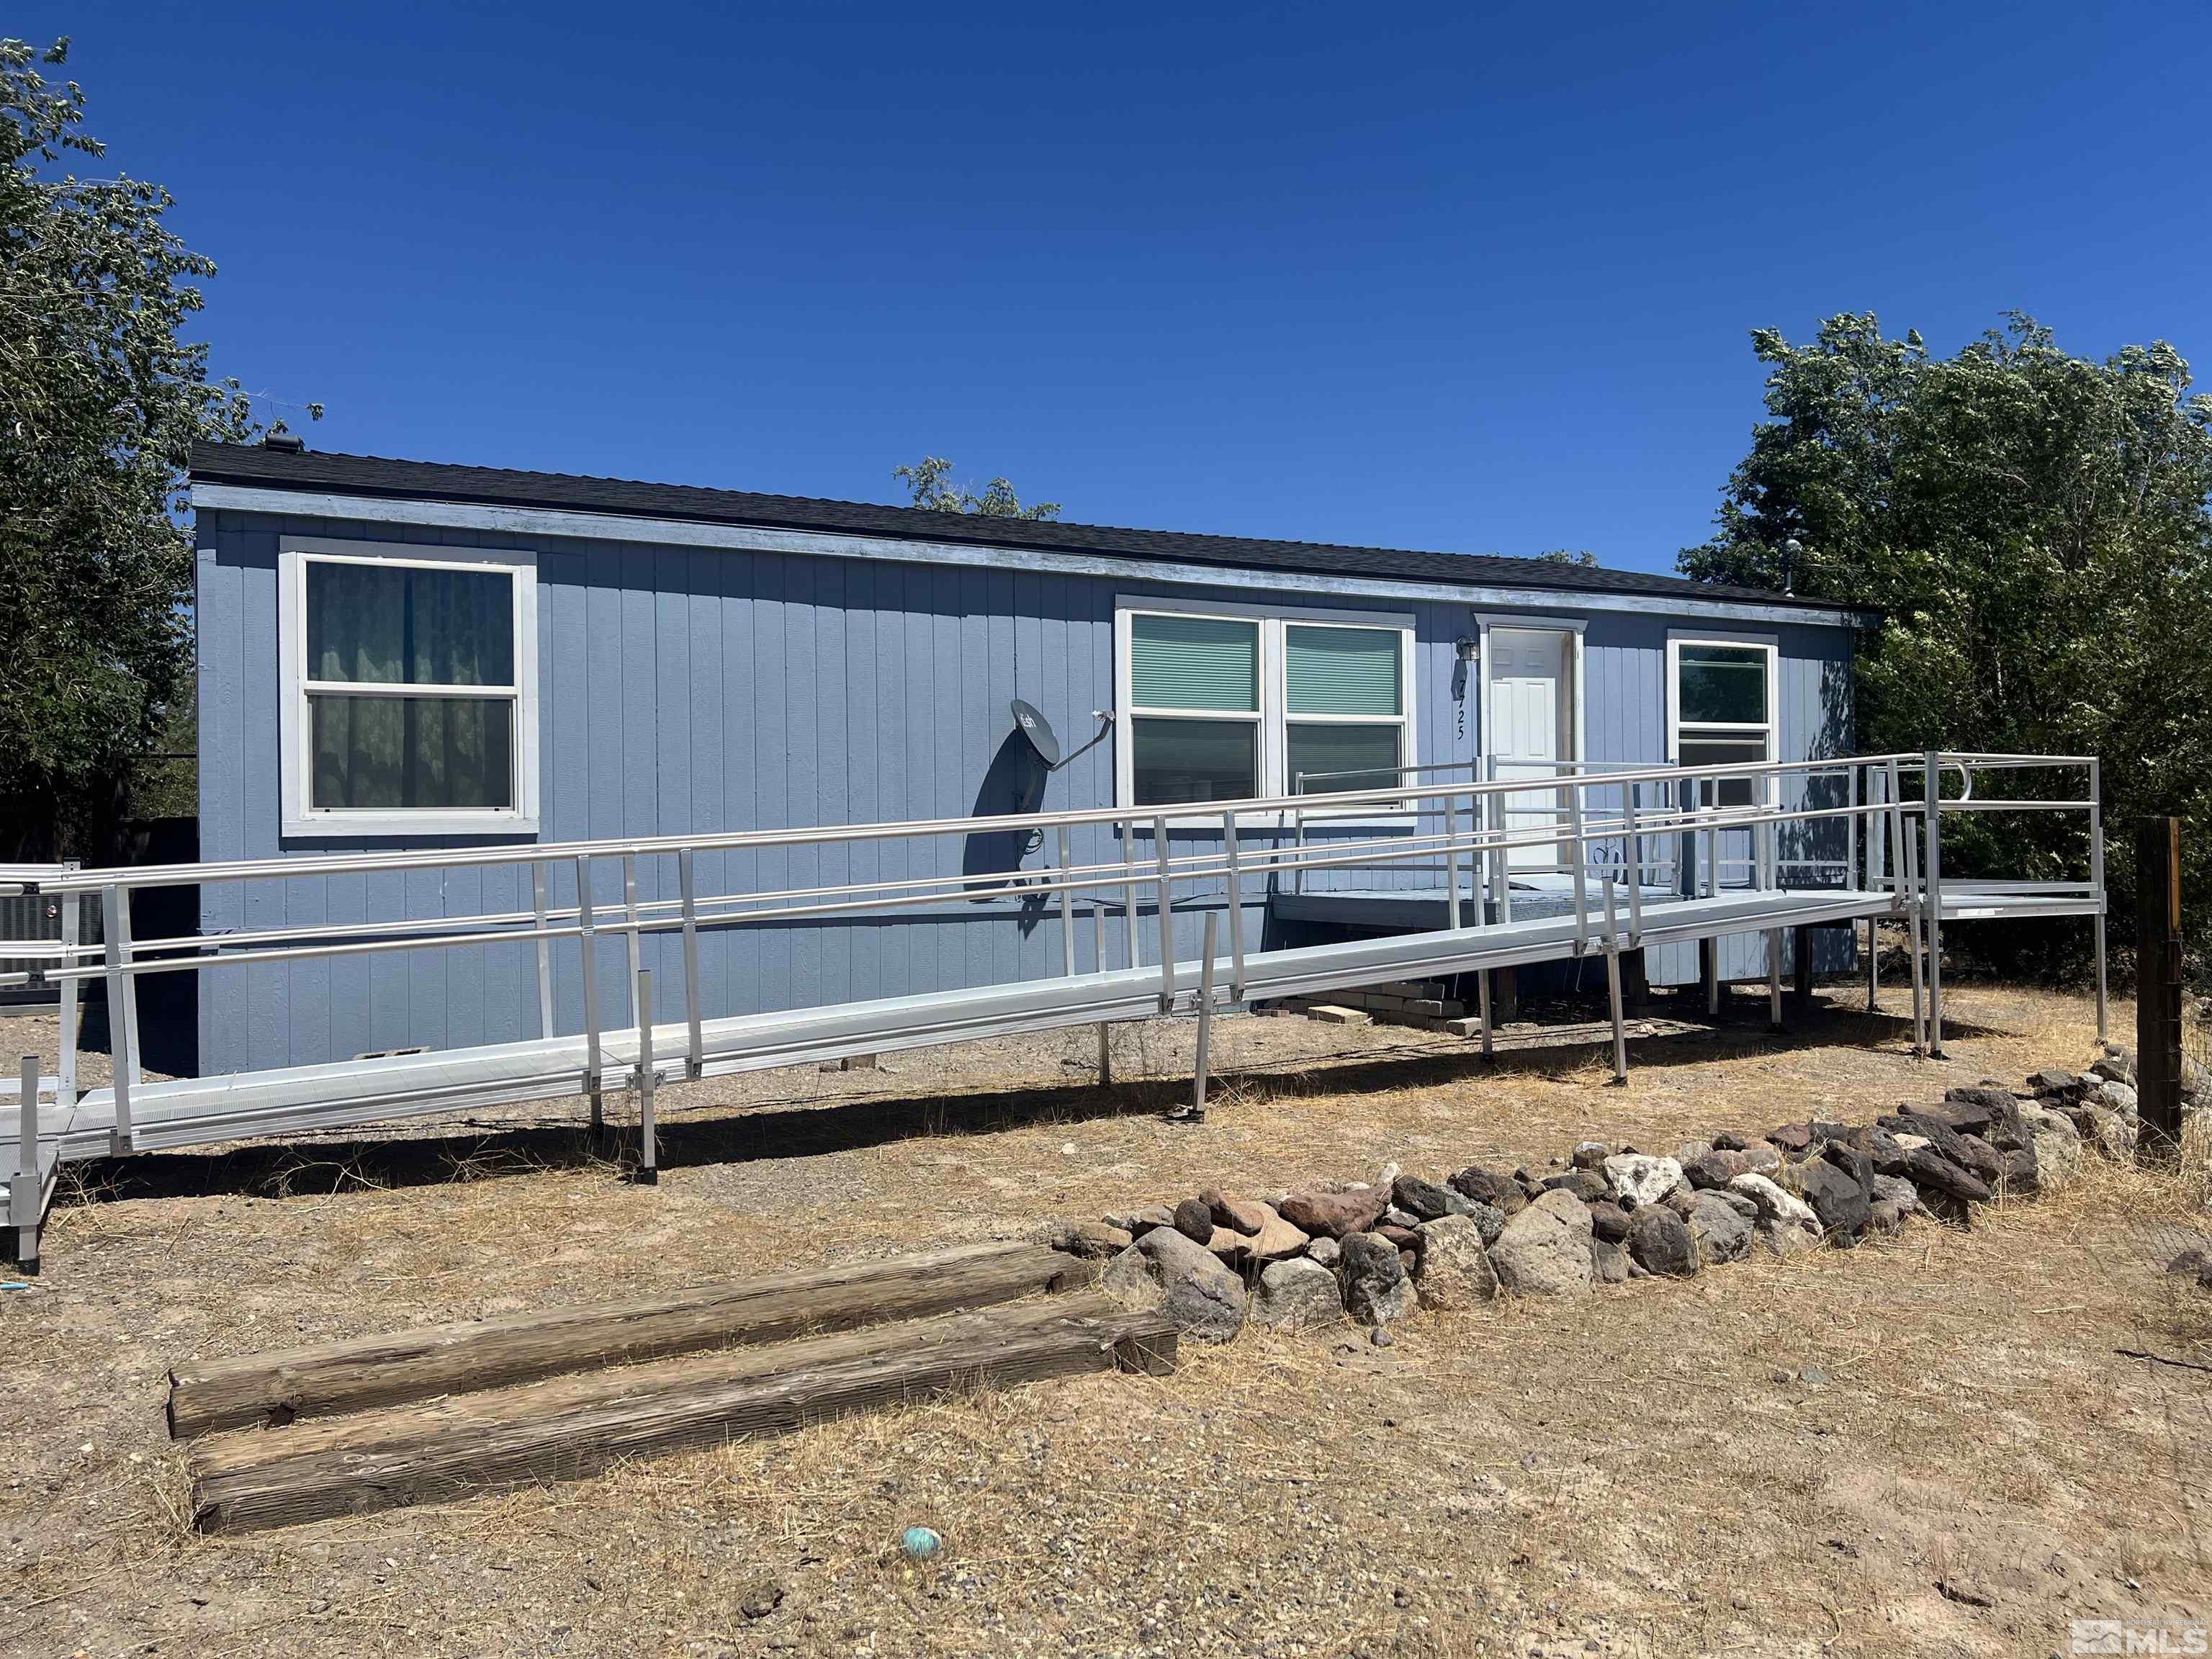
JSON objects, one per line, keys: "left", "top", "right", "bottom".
{"left": 168, "top": 1243, "right": 1097, "bottom": 1440}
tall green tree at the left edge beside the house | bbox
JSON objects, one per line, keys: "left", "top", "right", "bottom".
{"left": 0, "top": 40, "right": 318, "bottom": 858}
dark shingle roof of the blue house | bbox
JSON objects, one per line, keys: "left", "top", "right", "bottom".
{"left": 192, "top": 444, "right": 1856, "bottom": 621}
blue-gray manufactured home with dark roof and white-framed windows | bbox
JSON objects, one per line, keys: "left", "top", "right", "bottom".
{"left": 192, "top": 444, "right": 1865, "bottom": 1073}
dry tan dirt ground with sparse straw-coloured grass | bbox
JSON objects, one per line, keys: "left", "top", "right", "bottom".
{"left": 0, "top": 984, "right": 2212, "bottom": 1659}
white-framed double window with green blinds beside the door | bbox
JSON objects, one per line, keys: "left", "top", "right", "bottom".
{"left": 1115, "top": 597, "right": 1413, "bottom": 817}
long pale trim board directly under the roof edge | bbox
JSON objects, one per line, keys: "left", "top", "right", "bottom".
{"left": 192, "top": 485, "right": 1876, "bottom": 628}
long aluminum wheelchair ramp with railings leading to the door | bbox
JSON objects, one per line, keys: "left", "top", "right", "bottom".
{"left": 6, "top": 755, "right": 2103, "bottom": 1267}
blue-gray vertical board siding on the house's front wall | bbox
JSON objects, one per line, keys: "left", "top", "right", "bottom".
{"left": 197, "top": 511, "right": 1849, "bottom": 1073}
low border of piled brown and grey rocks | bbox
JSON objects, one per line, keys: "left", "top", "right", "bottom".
{"left": 1051, "top": 1042, "right": 2137, "bottom": 1343}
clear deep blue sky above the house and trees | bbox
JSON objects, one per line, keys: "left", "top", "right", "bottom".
{"left": 21, "top": 0, "right": 2212, "bottom": 569}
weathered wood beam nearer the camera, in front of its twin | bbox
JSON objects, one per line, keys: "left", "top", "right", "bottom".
{"left": 190, "top": 1292, "right": 1174, "bottom": 1533}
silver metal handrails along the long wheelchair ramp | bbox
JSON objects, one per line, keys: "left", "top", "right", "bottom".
{"left": 11, "top": 752, "right": 2103, "bottom": 1150}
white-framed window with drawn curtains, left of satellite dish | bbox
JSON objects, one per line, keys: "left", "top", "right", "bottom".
{"left": 276, "top": 537, "right": 537, "bottom": 836}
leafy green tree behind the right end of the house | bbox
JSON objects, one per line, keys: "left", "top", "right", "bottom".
{"left": 1679, "top": 312, "right": 2212, "bottom": 960}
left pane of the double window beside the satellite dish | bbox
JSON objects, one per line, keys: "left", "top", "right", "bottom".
{"left": 1130, "top": 613, "right": 1261, "bottom": 807}
